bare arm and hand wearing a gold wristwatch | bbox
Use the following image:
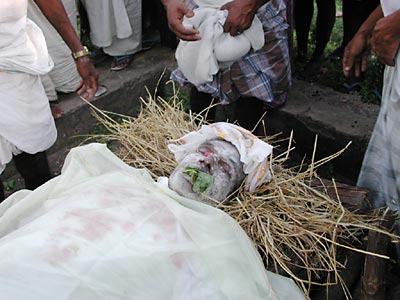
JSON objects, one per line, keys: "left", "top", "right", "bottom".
{"left": 35, "top": 0, "right": 99, "bottom": 99}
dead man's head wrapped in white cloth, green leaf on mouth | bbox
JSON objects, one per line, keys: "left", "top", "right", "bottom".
{"left": 168, "top": 122, "right": 272, "bottom": 202}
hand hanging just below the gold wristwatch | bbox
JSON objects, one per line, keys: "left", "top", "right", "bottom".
{"left": 76, "top": 56, "right": 99, "bottom": 100}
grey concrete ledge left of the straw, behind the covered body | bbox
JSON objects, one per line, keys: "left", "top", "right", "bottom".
{"left": 52, "top": 48, "right": 175, "bottom": 154}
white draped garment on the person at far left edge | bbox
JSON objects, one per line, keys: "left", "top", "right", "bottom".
{"left": 0, "top": 0, "right": 57, "bottom": 173}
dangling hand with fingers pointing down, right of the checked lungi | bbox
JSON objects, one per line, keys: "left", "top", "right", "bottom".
{"left": 342, "top": 33, "right": 369, "bottom": 77}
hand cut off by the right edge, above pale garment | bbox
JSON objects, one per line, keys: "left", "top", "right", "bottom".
{"left": 369, "top": 10, "right": 400, "bottom": 66}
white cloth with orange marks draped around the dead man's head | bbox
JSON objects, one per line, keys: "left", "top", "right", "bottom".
{"left": 168, "top": 122, "right": 272, "bottom": 192}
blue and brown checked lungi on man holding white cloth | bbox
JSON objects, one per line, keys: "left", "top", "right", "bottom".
{"left": 171, "top": 0, "right": 291, "bottom": 108}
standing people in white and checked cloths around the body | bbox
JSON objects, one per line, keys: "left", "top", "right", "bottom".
{"left": 0, "top": 0, "right": 400, "bottom": 296}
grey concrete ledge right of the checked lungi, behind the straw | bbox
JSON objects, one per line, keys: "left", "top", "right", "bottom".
{"left": 266, "top": 80, "right": 379, "bottom": 183}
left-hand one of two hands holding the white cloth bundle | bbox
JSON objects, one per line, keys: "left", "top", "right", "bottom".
{"left": 161, "top": 0, "right": 200, "bottom": 41}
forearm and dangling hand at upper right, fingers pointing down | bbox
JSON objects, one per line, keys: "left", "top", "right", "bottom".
{"left": 342, "top": 5, "right": 383, "bottom": 77}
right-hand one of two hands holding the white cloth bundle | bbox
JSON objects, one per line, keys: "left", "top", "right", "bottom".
{"left": 221, "top": 0, "right": 269, "bottom": 36}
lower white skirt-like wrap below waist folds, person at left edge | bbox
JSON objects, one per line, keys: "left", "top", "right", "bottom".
{"left": 0, "top": 72, "right": 57, "bottom": 173}
